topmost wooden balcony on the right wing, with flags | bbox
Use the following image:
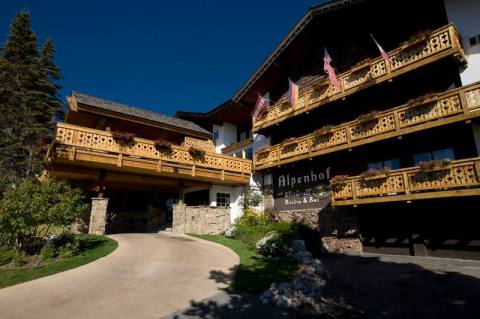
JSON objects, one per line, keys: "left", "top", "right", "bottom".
{"left": 252, "top": 24, "right": 466, "bottom": 132}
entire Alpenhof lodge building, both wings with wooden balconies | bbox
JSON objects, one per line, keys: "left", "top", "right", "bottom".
{"left": 48, "top": 0, "right": 480, "bottom": 259}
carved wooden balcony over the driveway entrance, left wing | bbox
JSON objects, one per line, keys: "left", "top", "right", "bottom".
{"left": 48, "top": 123, "right": 252, "bottom": 185}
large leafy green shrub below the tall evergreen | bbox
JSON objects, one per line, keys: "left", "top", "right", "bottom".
{"left": 0, "top": 179, "right": 86, "bottom": 254}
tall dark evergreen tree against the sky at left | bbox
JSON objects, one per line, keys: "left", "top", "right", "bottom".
{"left": 0, "top": 11, "right": 62, "bottom": 190}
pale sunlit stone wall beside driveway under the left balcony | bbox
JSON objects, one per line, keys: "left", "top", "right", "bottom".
{"left": 172, "top": 204, "right": 230, "bottom": 235}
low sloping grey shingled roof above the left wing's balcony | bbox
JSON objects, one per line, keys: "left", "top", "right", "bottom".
{"left": 72, "top": 92, "right": 210, "bottom": 138}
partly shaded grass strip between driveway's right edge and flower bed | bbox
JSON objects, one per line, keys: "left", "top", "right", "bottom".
{"left": 192, "top": 235, "right": 298, "bottom": 294}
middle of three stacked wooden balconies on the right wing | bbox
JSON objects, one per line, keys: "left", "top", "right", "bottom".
{"left": 254, "top": 82, "right": 480, "bottom": 170}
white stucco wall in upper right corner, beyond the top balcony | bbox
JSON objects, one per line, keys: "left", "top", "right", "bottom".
{"left": 445, "top": 0, "right": 480, "bottom": 85}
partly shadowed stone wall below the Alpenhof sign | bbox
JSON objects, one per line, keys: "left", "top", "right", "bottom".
{"left": 273, "top": 207, "right": 362, "bottom": 254}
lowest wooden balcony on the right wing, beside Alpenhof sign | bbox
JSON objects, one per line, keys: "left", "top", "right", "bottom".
{"left": 332, "top": 158, "right": 480, "bottom": 206}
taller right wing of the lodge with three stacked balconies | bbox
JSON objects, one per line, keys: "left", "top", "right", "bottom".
{"left": 183, "top": 0, "right": 480, "bottom": 259}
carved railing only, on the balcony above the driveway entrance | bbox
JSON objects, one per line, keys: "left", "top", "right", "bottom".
{"left": 55, "top": 123, "right": 252, "bottom": 178}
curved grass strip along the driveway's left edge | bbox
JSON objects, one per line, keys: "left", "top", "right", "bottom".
{"left": 0, "top": 235, "right": 118, "bottom": 288}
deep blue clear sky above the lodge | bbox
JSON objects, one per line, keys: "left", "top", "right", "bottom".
{"left": 0, "top": 0, "right": 323, "bottom": 115}
